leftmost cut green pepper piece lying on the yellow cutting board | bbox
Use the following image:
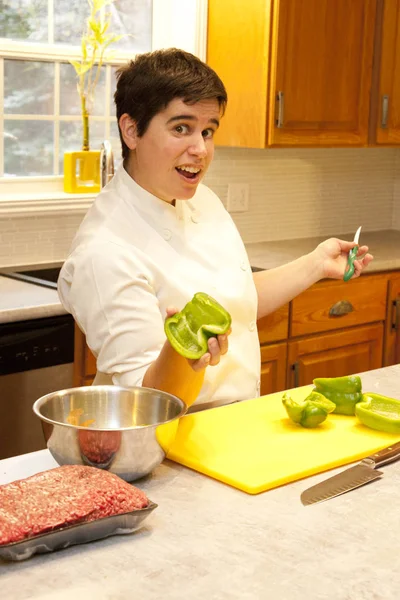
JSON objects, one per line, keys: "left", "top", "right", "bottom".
{"left": 282, "top": 392, "right": 336, "bottom": 429}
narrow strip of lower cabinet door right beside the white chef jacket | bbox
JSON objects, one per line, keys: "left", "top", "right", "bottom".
{"left": 261, "top": 342, "right": 287, "bottom": 396}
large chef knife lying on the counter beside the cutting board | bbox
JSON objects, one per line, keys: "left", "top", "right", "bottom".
{"left": 300, "top": 442, "right": 400, "bottom": 506}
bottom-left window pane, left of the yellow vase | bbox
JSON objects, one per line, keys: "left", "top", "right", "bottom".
{"left": 4, "top": 120, "right": 54, "bottom": 176}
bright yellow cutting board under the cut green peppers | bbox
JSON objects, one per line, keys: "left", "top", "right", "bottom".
{"left": 168, "top": 386, "right": 399, "bottom": 494}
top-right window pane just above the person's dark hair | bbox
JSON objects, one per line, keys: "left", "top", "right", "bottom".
{"left": 108, "top": 0, "right": 153, "bottom": 52}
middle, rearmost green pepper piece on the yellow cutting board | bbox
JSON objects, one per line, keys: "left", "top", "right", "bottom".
{"left": 313, "top": 375, "right": 362, "bottom": 415}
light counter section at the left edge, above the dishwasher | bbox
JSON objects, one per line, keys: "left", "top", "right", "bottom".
{"left": 0, "top": 275, "right": 67, "bottom": 323}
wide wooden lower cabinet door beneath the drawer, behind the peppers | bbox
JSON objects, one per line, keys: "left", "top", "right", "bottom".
{"left": 287, "top": 323, "right": 384, "bottom": 388}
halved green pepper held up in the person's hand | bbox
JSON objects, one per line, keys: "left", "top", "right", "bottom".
{"left": 164, "top": 292, "right": 232, "bottom": 360}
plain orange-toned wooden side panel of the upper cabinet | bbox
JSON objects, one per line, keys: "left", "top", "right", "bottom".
{"left": 207, "top": 0, "right": 271, "bottom": 148}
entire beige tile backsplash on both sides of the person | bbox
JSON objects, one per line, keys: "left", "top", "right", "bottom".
{"left": 0, "top": 148, "right": 400, "bottom": 267}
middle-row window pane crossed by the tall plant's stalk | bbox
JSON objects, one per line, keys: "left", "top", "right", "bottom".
{"left": 60, "top": 63, "right": 106, "bottom": 116}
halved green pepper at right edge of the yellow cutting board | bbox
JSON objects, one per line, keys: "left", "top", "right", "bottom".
{"left": 356, "top": 393, "right": 400, "bottom": 435}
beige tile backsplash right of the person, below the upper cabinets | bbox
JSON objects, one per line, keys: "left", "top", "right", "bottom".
{"left": 206, "top": 148, "right": 400, "bottom": 243}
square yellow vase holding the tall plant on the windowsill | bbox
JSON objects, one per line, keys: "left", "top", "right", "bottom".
{"left": 64, "top": 150, "right": 100, "bottom": 194}
